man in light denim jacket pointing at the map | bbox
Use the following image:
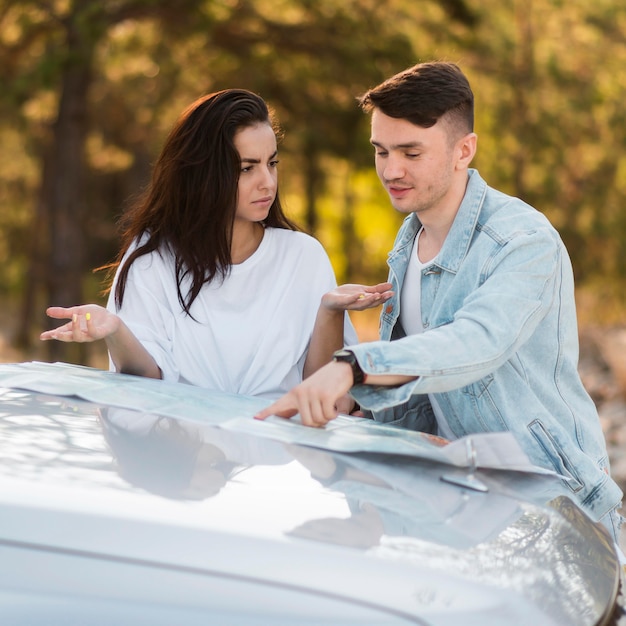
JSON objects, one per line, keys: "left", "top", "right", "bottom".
{"left": 256, "top": 62, "right": 622, "bottom": 539}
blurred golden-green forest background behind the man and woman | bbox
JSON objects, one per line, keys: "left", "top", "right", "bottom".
{"left": 0, "top": 0, "right": 626, "bottom": 372}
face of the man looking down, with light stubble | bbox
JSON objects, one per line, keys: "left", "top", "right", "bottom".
{"left": 371, "top": 109, "right": 458, "bottom": 221}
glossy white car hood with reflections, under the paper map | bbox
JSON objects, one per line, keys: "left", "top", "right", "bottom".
{"left": 0, "top": 364, "right": 617, "bottom": 626}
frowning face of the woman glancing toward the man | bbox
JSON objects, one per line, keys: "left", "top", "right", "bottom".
{"left": 234, "top": 124, "right": 278, "bottom": 222}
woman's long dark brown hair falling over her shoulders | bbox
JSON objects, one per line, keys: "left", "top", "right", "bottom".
{"left": 107, "top": 89, "right": 298, "bottom": 314}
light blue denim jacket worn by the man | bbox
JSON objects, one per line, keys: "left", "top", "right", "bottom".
{"left": 350, "top": 170, "right": 622, "bottom": 520}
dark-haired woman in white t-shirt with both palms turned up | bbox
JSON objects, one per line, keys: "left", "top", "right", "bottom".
{"left": 41, "top": 89, "right": 391, "bottom": 398}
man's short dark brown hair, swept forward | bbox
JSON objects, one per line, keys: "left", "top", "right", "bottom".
{"left": 359, "top": 61, "right": 474, "bottom": 134}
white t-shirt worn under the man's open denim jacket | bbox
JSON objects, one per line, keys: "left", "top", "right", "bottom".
{"left": 400, "top": 228, "right": 456, "bottom": 439}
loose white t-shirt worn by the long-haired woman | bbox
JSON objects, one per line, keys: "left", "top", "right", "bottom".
{"left": 107, "top": 228, "right": 358, "bottom": 399}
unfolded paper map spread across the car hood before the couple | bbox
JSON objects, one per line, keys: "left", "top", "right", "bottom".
{"left": 0, "top": 361, "right": 556, "bottom": 476}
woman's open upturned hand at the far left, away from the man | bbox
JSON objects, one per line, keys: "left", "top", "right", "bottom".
{"left": 39, "top": 304, "right": 121, "bottom": 343}
